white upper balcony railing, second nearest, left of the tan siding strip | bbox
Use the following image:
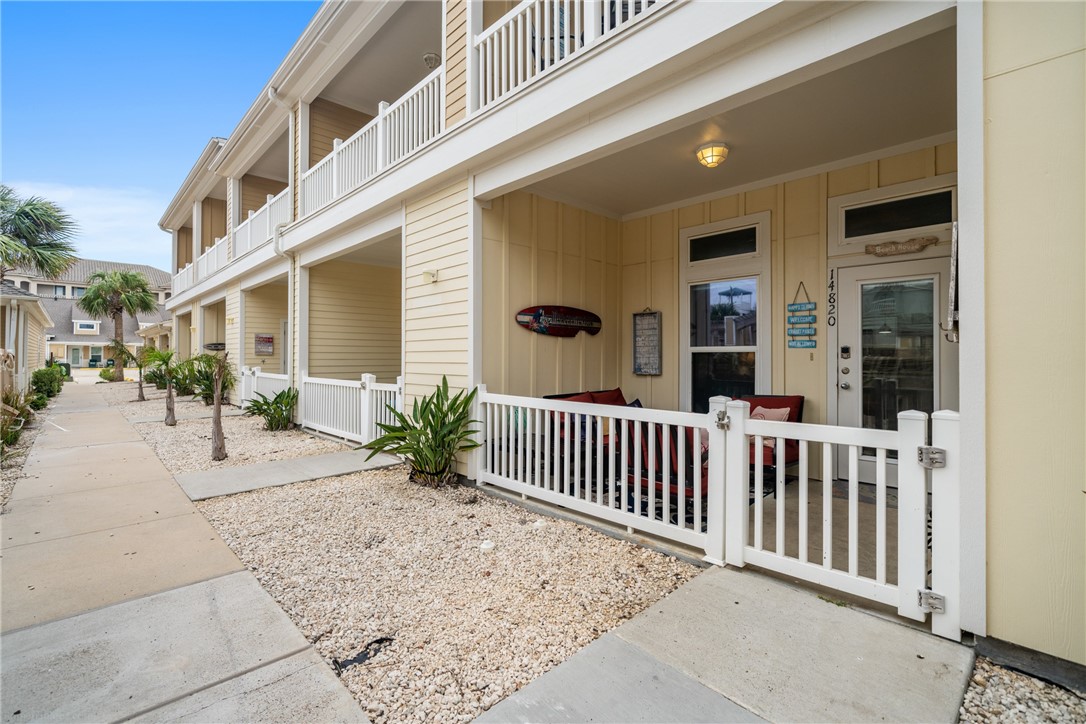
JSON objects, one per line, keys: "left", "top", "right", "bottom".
{"left": 299, "top": 67, "right": 444, "bottom": 216}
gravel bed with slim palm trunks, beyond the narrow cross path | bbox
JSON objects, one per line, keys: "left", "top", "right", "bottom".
{"left": 132, "top": 412, "right": 351, "bottom": 473}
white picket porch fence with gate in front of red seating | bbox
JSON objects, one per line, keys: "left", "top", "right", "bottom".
{"left": 475, "top": 385, "right": 961, "bottom": 639}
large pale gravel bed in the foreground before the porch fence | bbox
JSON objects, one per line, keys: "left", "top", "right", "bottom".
{"left": 198, "top": 467, "right": 698, "bottom": 724}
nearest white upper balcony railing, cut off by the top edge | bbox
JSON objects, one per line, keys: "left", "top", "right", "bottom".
{"left": 471, "top": 0, "right": 668, "bottom": 110}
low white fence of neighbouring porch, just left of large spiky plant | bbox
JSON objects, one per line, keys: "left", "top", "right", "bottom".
{"left": 302, "top": 374, "right": 403, "bottom": 444}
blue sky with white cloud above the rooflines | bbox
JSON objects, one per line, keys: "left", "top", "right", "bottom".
{"left": 0, "top": 0, "right": 320, "bottom": 269}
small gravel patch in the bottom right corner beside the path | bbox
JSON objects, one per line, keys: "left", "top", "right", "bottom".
{"left": 959, "top": 657, "right": 1086, "bottom": 724}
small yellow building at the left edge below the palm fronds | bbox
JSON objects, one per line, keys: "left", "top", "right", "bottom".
{"left": 0, "top": 280, "right": 53, "bottom": 392}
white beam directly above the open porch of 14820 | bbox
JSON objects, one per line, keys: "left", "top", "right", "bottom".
{"left": 476, "top": 2, "right": 954, "bottom": 199}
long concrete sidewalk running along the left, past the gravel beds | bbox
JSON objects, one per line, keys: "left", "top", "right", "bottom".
{"left": 0, "top": 384, "right": 366, "bottom": 722}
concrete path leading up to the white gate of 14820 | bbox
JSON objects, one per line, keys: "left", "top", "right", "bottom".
{"left": 476, "top": 568, "right": 973, "bottom": 722}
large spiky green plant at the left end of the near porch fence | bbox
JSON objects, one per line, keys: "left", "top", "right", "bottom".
{"left": 365, "top": 376, "right": 480, "bottom": 487}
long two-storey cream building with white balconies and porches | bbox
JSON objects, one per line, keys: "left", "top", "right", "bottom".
{"left": 160, "top": 0, "right": 1086, "bottom": 681}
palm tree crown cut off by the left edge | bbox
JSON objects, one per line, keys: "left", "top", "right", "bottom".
{"left": 0, "top": 185, "right": 78, "bottom": 281}
